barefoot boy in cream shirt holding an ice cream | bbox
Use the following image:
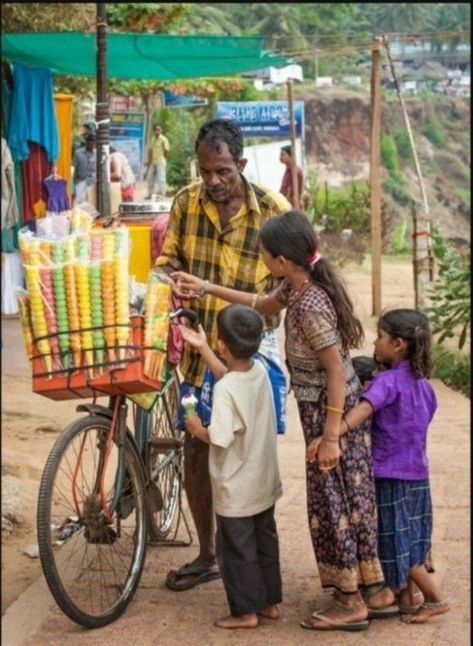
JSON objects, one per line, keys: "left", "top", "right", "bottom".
{"left": 181, "top": 305, "right": 282, "bottom": 629}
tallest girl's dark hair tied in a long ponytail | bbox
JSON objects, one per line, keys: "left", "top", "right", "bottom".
{"left": 260, "top": 210, "right": 364, "bottom": 349}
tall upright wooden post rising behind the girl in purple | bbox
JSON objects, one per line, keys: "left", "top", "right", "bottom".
{"left": 370, "top": 38, "right": 382, "bottom": 316}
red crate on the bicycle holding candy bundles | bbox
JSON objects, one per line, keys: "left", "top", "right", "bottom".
{"left": 33, "top": 316, "right": 166, "bottom": 400}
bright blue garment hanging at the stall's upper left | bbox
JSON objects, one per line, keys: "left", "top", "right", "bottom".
{"left": 8, "top": 63, "right": 59, "bottom": 162}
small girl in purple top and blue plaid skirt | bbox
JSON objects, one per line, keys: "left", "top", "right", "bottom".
{"left": 340, "top": 309, "right": 449, "bottom": 624}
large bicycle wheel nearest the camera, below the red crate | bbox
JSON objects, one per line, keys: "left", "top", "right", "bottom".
{"left": 37, "top": 415, "right": 147, "bottom": 628}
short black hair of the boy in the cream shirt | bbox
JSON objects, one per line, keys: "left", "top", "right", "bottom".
{"left": 217, "top": 305, "right": 263, "bottom": 359}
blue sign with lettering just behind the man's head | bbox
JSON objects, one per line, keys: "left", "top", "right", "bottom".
{"left": 216, "top": 101, "right": 304, "bottom": 137}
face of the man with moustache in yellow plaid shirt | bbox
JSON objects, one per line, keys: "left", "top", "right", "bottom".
{"left": 197, "top": 141, "right": 247, "bottom": 202}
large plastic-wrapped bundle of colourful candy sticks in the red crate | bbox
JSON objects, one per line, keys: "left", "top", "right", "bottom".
{"left": 19, "top": 221, "right": 130, "bottom": 377}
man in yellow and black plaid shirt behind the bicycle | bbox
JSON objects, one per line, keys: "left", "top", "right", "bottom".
{"left": 156, "top": 119, "right": 291, "bottom": 590}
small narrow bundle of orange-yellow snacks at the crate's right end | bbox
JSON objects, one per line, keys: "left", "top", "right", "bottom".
{"left": 143, "top": 272, "right": 172, "bottom": 381}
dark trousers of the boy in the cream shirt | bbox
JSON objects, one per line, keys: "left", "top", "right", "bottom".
{"left": 217, "top": 505, "right": 282, "bottom": 617}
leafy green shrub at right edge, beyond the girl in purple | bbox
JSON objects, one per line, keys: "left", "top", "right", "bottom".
{"left": 426, "top": 226, "right": 471, "bottom": 350}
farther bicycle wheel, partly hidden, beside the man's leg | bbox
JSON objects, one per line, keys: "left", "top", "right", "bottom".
{"left": 136, "top": 373, "right": 182, "bottom": 541}
